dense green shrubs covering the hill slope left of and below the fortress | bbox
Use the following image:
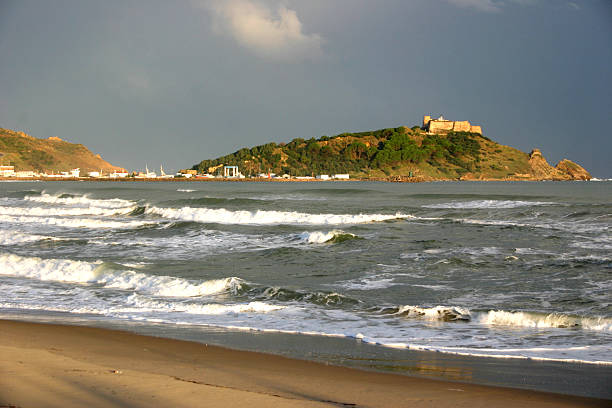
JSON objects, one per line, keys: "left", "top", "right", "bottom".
{"left": 193, "top": 127, "right": 480, "bottom": 176}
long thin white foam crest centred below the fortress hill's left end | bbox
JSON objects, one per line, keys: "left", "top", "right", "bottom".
{"left": 146, "top": 207, "right": 410, "bottom": 225}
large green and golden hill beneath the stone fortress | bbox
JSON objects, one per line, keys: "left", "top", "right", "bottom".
{"left": 193, "top": 126, "right": 591, "bottom": 181}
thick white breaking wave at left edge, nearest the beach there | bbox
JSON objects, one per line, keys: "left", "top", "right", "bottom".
{"left": 0, "top": 254, "right": 243, "bottom": 297}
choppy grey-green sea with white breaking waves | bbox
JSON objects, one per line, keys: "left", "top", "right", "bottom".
{"left": 0, "top": 181, "right": 612, "bottom": 394}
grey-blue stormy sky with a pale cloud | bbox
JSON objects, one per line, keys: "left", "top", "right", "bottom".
{"left": 0, "top": 0, "right": 612, "bottom": 177}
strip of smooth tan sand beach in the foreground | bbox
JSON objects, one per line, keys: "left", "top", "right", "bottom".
{"left": 0, "top": 320, "right": 610, "bottom": 407}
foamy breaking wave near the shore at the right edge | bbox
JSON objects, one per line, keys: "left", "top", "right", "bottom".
{"left": 478, "top": 310, "right": 612, "bottom": 331}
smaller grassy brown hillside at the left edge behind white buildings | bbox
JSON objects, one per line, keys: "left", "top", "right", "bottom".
{"left": 0, "top": 128, "right": 121, "bottom": 172}
